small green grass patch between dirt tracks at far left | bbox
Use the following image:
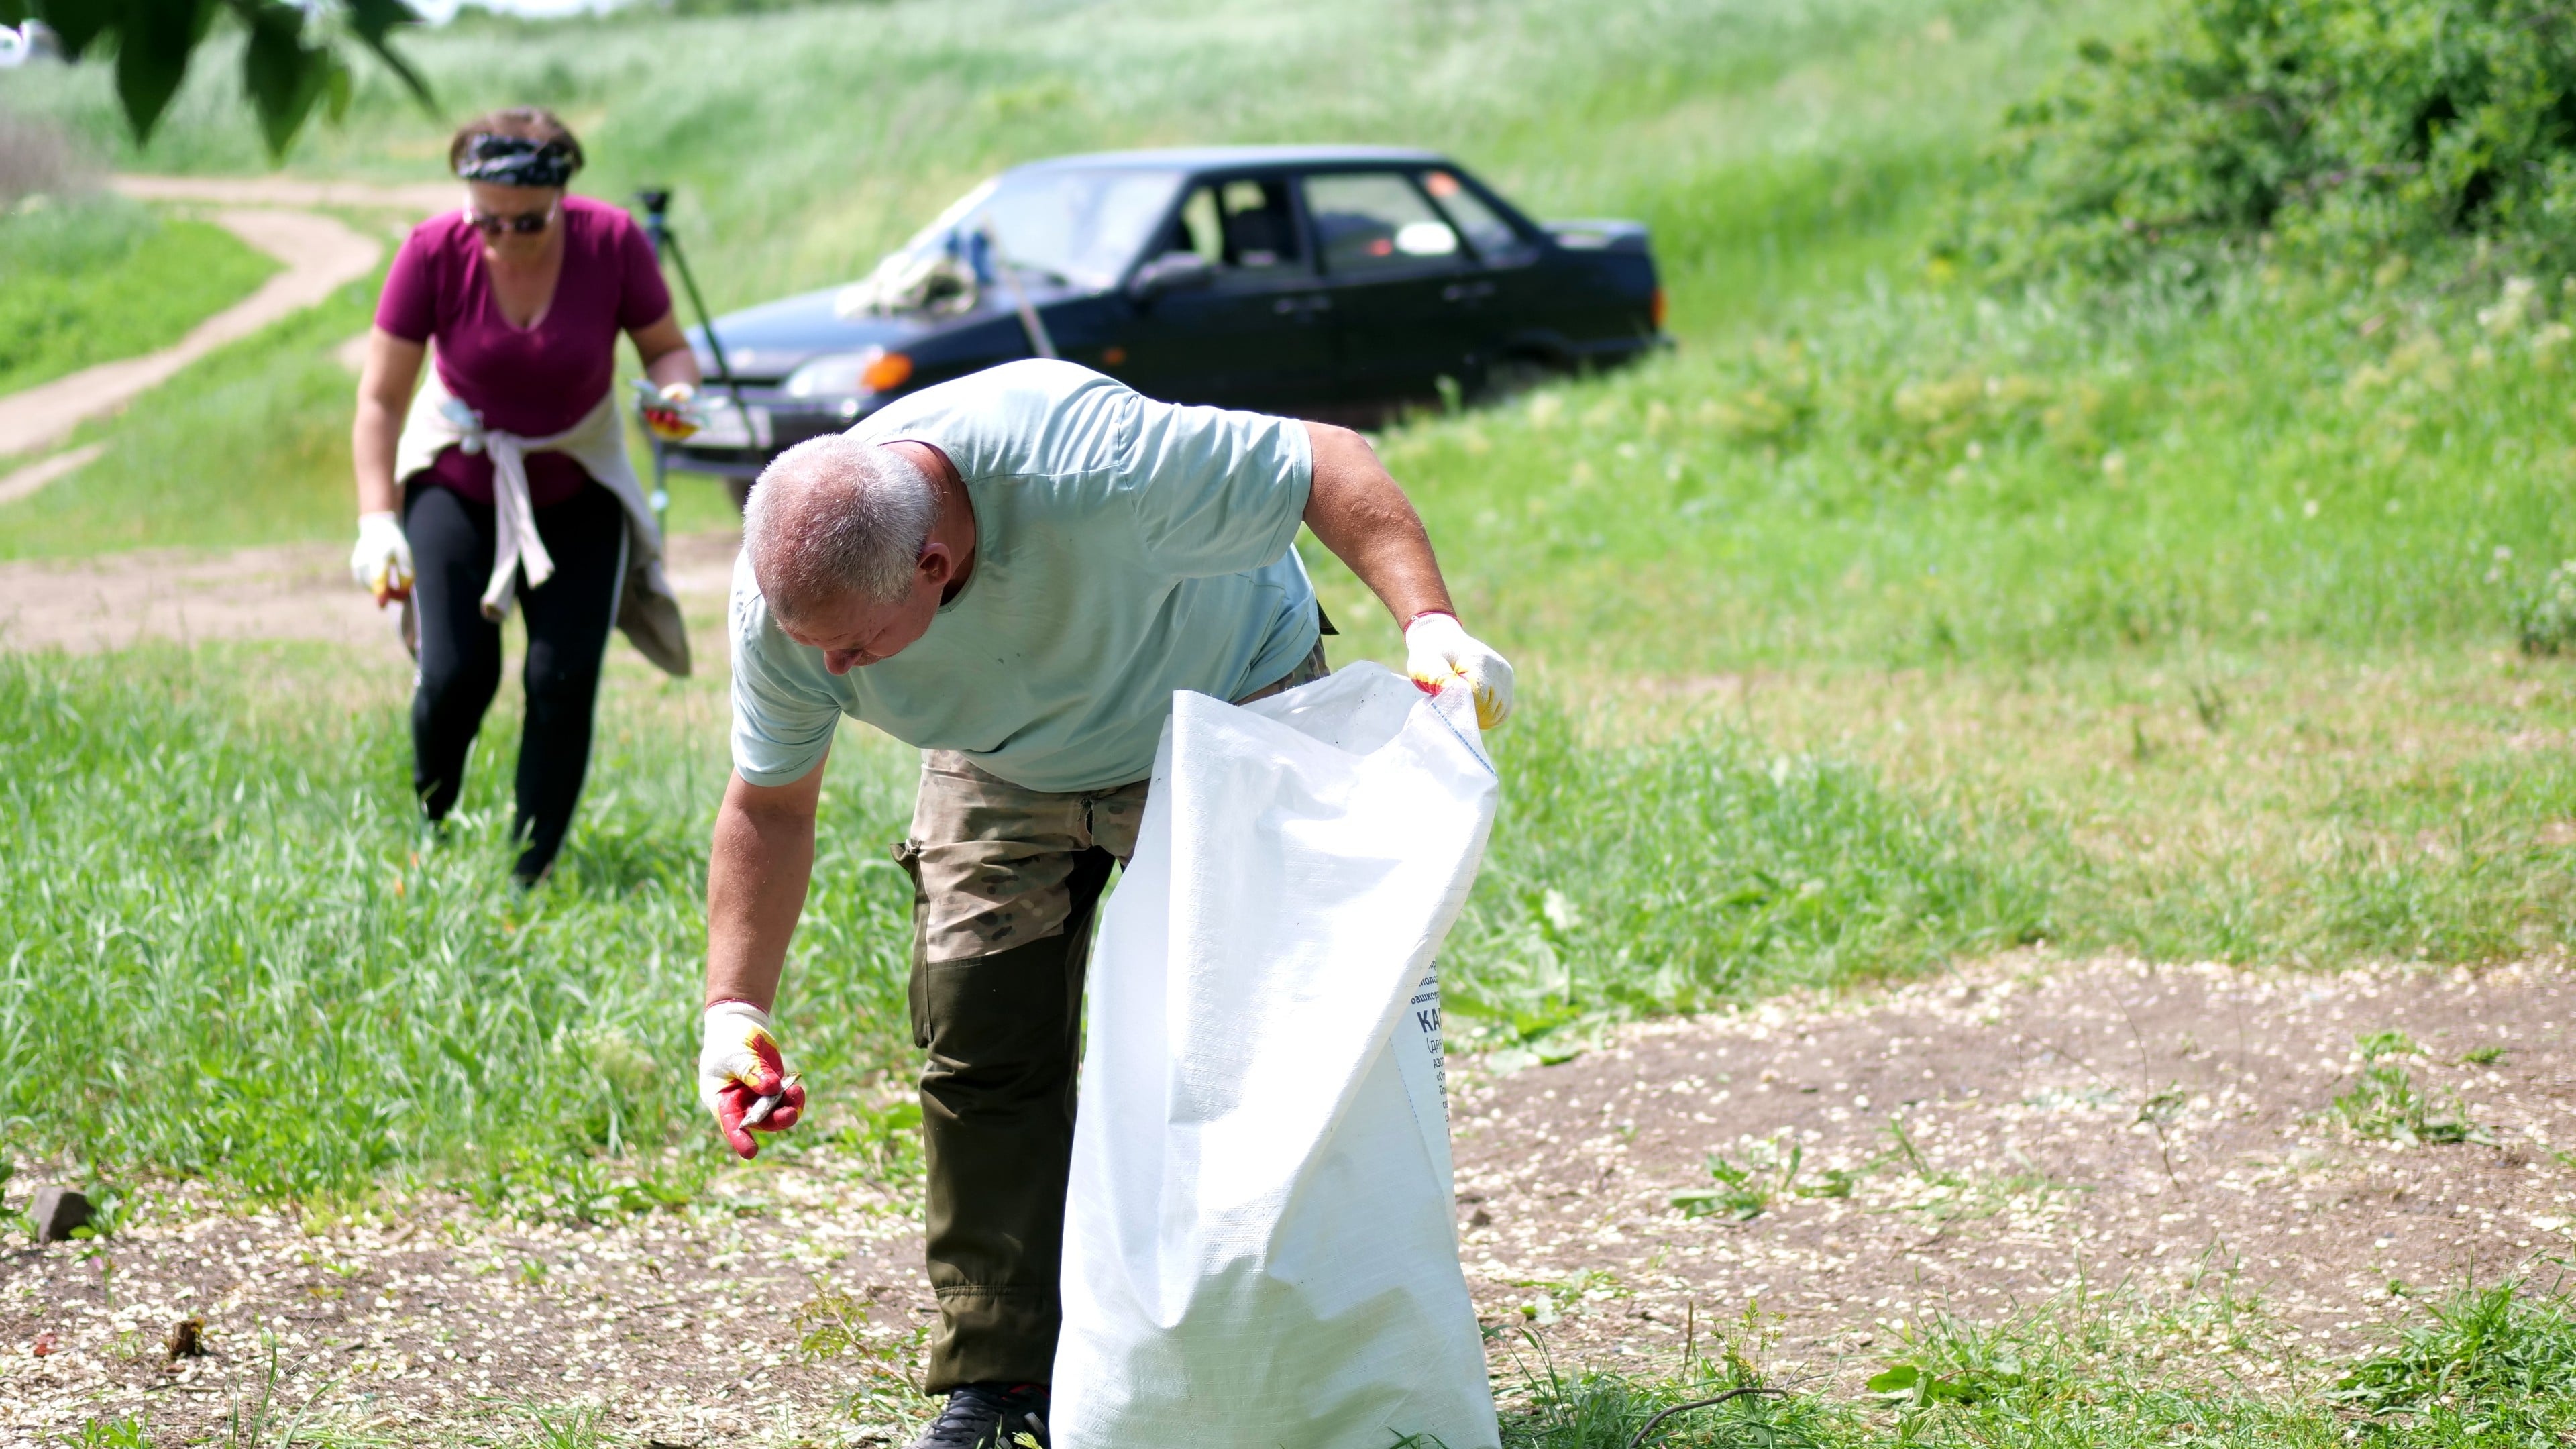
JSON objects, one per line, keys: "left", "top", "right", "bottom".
{"left": 0, "top": 196, "right": 278, "bottom": 394}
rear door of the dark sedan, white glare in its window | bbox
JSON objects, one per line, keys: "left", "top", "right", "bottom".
{"left": 1306, "top": 170, "right": 1487, "bottom": 405}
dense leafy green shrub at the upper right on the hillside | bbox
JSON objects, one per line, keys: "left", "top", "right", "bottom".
{"left": 1945, "top": 0, "right": 2576, "bottom": 281}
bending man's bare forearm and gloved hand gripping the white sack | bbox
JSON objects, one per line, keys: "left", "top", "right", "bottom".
{"left": 1303, "top": 423, "right": 1512, "bottom": 730}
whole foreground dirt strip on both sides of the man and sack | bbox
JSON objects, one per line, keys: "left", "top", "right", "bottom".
{"left": 0, "top": 962, "right": 2576, "bottom": 1444}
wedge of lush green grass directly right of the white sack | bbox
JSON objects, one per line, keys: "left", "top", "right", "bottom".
{"left": 1442, "top": 704, "right": 2053, "bottom": 1036}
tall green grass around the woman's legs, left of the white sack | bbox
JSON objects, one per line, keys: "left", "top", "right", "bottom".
{"left": 0, "top": 652, "right": 910, "bottom": 1207}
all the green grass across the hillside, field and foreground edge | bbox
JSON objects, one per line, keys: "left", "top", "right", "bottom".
{"left": 15, "top": 0, "right": 2576, "bottom": 1449}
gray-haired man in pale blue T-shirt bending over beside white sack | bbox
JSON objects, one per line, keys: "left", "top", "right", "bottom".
{"left": 698, "top": 361, "right": 1512, "bottom": 1449}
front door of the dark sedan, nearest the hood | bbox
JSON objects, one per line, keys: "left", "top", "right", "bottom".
{"left": 1105, "top": 175, "right": 1334, "bottom": 413}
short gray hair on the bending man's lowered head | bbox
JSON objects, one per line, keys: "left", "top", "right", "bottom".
{"left": 742, "top": 433, "right": 941, "bottom": 619}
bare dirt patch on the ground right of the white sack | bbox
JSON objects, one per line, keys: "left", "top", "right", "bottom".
{"left": 1456, "top": 962, "right": 2576, "bottom": 1366}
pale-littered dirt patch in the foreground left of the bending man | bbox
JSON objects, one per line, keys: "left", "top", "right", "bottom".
{"left": 0, "top": 1152, "right": 930, "bottom": 1449}
